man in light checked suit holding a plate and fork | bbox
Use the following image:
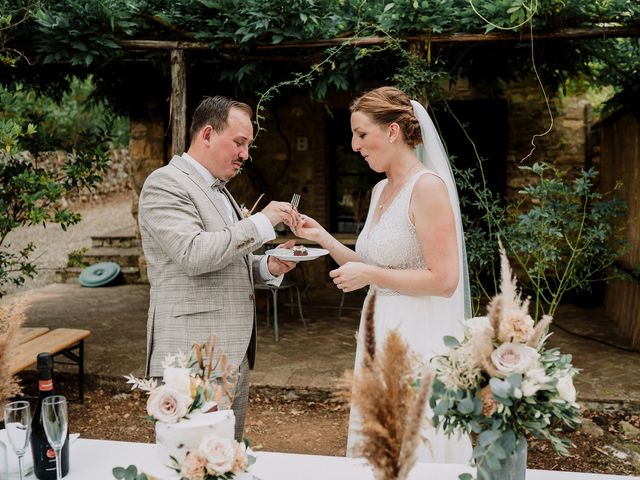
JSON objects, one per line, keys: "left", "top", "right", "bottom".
{"left": 138, "top": 96, "right": 299, "bottom": 440}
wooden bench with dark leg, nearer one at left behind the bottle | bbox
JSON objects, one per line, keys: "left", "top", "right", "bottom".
{"left": 11, "top": 327, "right": 91, "bottom": 402}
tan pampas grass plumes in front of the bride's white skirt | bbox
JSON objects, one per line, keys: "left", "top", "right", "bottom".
{"left": 340, "top": 291, "right": 433, "bottom": 480}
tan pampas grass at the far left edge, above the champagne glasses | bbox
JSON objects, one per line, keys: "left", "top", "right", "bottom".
{"left": 0, "top": 298, "right": 27, "bottom": 403}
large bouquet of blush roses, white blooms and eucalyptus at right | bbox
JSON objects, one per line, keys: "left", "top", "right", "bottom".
{"left": 430, "top": 245, "right": 580, "bottom": 478}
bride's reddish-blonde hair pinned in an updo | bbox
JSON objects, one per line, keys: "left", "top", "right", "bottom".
{"left": 349, "top": 87, "right": 422, "bottom": 147}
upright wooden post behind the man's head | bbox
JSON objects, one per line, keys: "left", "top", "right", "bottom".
{"left": 171, "top": 49, "right": 187, "bottom": 155}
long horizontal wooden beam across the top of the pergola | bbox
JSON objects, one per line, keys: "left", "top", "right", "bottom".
{"left": 119, "top": 26, "right": 640, "bottom": 52}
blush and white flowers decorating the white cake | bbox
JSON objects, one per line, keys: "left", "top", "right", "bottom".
{"left": 112, "top": 337, "right": 255, "bottom": 480}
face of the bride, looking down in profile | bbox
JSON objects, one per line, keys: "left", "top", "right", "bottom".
{"left": 351, "top": 112, "right": 390, "bottom": 172}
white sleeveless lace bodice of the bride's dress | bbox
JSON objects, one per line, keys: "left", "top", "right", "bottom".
{"left": 356, "top": 170, "right": 431, "bottom": 294}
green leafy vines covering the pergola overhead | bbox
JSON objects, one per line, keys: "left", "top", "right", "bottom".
{"left": 0, "top": 0, "right": 640, "bottom": 108}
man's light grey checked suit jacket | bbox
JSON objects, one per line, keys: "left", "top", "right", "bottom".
{"left": 138, "top": 156, "right": 262, "bottom": 376}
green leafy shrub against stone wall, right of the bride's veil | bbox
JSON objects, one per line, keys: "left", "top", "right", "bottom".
{"left": 458, "top": 163, "right": 626, "bottom": 318}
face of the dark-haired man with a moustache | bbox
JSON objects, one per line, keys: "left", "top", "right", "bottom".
{"left": 208, "top": 108, "right": 253, "bottom": 181}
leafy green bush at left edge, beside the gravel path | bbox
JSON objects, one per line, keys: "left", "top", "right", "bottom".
{"left": 0, "top": 79, "right": 117, "bottom": 297}
